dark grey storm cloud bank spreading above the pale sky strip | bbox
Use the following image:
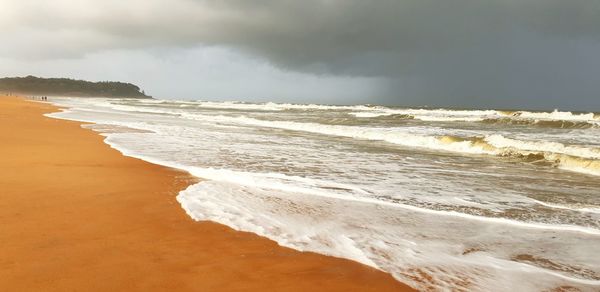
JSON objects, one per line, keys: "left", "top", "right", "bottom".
{"left": 0, "top": 0, "right": 600, "bottom": 108}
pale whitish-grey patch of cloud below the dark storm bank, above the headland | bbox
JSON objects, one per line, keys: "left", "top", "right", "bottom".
{"left": 0, "top": 47, "right": 385, "bottom": 103}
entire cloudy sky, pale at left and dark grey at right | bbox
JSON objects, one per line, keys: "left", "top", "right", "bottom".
{"left": 0, "top": 0, "right": 600, "bottom": 111}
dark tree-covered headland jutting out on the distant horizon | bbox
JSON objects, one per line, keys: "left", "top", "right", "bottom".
{"left": 0, "top": 76, "right": 151, "bottom": 98}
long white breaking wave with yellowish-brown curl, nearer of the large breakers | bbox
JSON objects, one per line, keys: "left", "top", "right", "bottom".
{"left": 178, "top": 114, "right": 600, "bottom": 175}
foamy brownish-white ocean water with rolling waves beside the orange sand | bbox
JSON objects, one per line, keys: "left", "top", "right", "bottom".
{"left": 49, "top": 98, "right": 600, "bottom": 291}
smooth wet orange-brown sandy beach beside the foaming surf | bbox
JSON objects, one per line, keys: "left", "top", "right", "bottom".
{"left": 0, "top": 97, "right": 410, "bottom": 291}
